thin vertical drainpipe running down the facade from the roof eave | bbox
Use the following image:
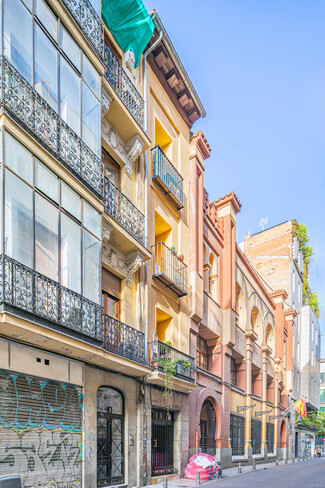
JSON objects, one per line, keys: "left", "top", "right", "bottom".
{"left": 143, "top": 25, "right": 163, "bottom": 363}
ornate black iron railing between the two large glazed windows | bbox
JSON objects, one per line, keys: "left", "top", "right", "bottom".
{"left": 0, "top": 56, "right": 103, "bottom": 197}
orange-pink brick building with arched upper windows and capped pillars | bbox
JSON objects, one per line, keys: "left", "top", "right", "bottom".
{"left": 190, "top": 132, "right": 289, "bottom": 466}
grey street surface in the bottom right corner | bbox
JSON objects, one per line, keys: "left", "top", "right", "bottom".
{"left": 207, "top": 457, "right": 325, "bottom": 488}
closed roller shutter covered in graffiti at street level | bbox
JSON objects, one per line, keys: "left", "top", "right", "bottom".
{"left": 0, "top": 370, "right": 83, "bottom": 488}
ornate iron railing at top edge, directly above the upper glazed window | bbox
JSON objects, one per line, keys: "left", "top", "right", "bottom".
{"left": 62, "top": 0, "right": 104, "bottom": 61}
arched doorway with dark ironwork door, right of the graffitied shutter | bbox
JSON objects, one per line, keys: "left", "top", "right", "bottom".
{"left": 97, "top": 386, "right": 124, "bottom": 486}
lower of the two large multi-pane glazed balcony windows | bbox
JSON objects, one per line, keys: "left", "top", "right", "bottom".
{"left": 4, "top": 133, "right": 101, "bottom": 303}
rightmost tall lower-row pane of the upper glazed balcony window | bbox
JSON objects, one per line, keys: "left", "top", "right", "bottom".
{"left": 82, "top": 83, "right": 100, "bottom": 155}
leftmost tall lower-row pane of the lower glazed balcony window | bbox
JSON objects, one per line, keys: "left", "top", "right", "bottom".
{"left": 5, "top": 170, "right": 33, "bottom": 268}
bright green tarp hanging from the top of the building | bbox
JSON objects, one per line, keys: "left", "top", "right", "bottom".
{"left": 102, "top": 0, "right": 155, "bottom": 67}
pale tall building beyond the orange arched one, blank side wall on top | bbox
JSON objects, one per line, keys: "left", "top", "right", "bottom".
{"left": 244, "top": 221, "right": 320, "bottom": 457}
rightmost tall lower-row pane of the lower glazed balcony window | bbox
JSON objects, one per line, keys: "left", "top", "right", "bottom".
{"left": 83, "top": 230, "right": 101, "bottom": 303}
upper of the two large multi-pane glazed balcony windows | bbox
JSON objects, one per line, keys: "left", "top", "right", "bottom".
{"left": 2, "top": 0, "right": 101, "bottom": 156}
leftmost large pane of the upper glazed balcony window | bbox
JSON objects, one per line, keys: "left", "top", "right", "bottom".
{"left": 3, "top": 0, "right": 33, "bottom": 83}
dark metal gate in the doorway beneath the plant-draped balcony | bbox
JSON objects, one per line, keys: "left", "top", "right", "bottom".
{"left": 151, "top": 409, "right": 176, "bottom": 476}
